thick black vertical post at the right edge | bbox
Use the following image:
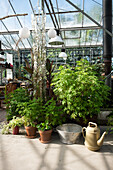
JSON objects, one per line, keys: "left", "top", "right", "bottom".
{"left": 103, "top": 0, "right": 112, "bottom": 86}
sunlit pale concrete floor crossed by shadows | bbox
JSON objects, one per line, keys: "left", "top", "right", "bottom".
{"left": 0, "top": 110, "right": 113, "bottom": 170}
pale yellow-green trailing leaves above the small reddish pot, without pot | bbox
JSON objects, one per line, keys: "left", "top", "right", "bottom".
{"left": 2, "top": 116, "right": 24, "bottom": 134}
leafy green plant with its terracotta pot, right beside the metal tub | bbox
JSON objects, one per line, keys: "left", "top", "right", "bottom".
{"left": 37, "top": 98, "right": 65, "bottom": 143}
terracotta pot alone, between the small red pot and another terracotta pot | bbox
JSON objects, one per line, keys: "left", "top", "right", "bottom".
{"left": 25, "top": 126, "right": 36, "bottom": 138}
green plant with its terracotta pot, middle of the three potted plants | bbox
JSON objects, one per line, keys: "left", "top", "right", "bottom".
{"left": 20, "top": 98, "right": 42, "bottom": 138}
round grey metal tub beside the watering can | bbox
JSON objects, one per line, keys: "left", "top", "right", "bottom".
{"left": 56, "top": 124, "right": 82, "bottom": 144}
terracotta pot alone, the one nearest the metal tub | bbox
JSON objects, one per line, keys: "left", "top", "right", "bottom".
{"left": 39, "top": 129, "right": 52, "bottom": 143}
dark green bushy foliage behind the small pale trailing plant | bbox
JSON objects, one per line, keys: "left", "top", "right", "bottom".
{"left": 5, "top": 88, "right": 30, "bottom": 121}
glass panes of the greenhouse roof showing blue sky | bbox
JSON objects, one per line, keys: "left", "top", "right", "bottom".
{"left": 0, "top": 0, "right": 110, "bottom": 50}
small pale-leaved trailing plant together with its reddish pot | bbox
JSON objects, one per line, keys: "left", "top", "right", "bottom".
{"left": 2, "top": 116, "right": 24, "bottom": 135}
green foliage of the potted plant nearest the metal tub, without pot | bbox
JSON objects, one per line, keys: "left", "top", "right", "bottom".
{"left": 37, "top": 99, "right": 65, "bottom": 131}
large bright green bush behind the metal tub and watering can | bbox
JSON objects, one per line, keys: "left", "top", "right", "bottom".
{"left": 52, "top": 59, "right": 110, "bottom": 120}
